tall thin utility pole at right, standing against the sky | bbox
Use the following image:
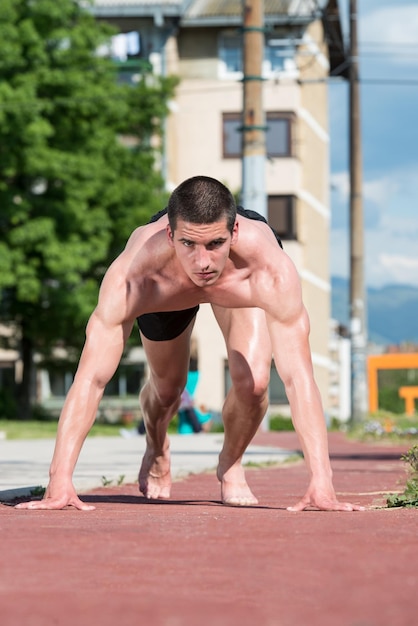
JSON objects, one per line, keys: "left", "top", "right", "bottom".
{"left": 350, "top": 0, "right": 367, "bottom": 424}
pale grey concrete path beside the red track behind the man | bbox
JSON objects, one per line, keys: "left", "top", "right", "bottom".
{"left": 0, "top": 431, "right": 296, "bottom": 500}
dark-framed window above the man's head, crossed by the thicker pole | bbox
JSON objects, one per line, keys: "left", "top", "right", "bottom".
{"left": 222, "top": 111, "right": 294, "bottom": 159}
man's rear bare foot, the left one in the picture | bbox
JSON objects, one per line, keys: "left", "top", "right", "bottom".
{"left": 138, "top": 447, "right": 171, "bottom": 500}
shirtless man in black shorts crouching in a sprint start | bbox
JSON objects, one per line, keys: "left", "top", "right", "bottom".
{"left": 18, "top": 176, "right": 362, "bottom": 511}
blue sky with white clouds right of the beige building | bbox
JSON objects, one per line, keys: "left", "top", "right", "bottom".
{"left": 329, "top": 0, "right": 418, "bottom": 287}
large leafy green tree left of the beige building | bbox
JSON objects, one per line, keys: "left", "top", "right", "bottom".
{"left": 0, "top": 0, "right": 176, "bottom": 419}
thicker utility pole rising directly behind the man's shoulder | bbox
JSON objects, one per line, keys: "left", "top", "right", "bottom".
{"left": 241, "top": 0, "right": 268, "bottom": 219}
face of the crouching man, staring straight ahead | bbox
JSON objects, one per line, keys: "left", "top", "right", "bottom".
{"left": 167, "top": 219, "right": 238, "bottom": 287}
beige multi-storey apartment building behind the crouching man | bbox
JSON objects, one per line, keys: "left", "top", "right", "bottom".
{"left": 93, "top": 0, "right": 344, "bottom": 411}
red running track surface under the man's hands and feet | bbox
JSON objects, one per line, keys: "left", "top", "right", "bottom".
{"left": 0, "top": 433, "right": 418, "bottom": 626}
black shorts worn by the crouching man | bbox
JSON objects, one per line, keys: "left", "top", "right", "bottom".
{"left": 137, "top": 206, "right": 283, "bottom": 341}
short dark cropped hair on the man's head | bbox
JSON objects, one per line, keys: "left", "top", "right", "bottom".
{"left": 167, "top": 176, "right": 237, "bottom": 233}
